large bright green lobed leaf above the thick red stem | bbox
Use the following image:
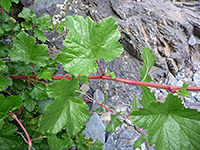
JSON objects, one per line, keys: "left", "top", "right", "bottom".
{"left": 56, "top": 16, "right": 123, "bottom": 76}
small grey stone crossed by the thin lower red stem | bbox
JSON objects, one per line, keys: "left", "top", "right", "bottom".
{"left": 91, "top": 89, "right": 105, "bottom": 111}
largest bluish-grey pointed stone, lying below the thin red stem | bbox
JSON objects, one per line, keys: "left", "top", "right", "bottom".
{"left": 84, "top": 114, "right": 106, "bottom": 143}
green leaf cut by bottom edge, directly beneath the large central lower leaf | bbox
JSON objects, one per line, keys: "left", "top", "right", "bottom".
{"left": 48, "top": 134, "right": 74, "bottom": 150}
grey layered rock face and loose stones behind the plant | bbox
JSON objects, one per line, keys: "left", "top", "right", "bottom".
{"left": 21, "top": 0, "right": 200, "bottom": 150}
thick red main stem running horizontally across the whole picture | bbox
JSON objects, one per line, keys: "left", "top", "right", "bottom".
{"left": 8, "top": 75, "right": 200, "bottom": 91}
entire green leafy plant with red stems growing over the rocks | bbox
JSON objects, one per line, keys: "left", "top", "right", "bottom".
{"left": 0, "top": 4, "right": 200, "bottom": 150}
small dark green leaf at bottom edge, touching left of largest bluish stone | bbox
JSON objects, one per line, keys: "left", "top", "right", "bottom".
{"left": 75, "top": 132, "right": 93, "bottom": 150}
